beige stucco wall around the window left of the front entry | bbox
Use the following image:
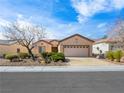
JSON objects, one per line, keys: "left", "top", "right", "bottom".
{"left": 33, "top": 41, "right": 52, "bottom": 54}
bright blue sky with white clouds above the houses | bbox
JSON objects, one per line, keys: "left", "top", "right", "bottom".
{"left": 0, "top": 0, "right": 124, "bottom": 39}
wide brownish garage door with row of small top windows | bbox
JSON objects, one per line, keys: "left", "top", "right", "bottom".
{"left": 64, "top": 45, "right": 89, "bottom": 57}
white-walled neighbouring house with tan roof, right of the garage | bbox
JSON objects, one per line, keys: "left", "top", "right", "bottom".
{"left": 92, "top": 39, "right": 115, "bottom": 54}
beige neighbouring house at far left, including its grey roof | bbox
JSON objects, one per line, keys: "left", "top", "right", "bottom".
{"left": 0, "top": 40, "right": 27, "bottom": 54}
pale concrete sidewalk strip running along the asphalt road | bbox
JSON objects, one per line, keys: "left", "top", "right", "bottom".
{"left": 0, "top": 66, "right": 124, "bottom": 72}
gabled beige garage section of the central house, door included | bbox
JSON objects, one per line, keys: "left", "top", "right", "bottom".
{"left": 59, "top": 34, "right": 94, "bottom": 57}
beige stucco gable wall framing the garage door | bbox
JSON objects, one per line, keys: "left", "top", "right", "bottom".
{"left": 58, "top": 36, "right": 93, "bottom": 56}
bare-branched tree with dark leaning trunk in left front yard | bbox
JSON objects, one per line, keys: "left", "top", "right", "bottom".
{"left": 3, "top": 21, "right": 45, "bottom": 60}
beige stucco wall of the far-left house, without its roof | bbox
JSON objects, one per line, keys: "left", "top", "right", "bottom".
{"left": 0, "top": 43, "right": 27, "bottom": 54}
